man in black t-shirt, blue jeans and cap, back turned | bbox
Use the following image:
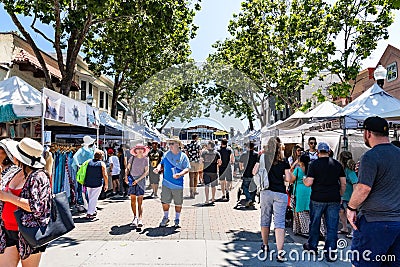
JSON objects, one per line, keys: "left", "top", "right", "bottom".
{"left": 303, "top": 142, "right": 346, "bottom": 261}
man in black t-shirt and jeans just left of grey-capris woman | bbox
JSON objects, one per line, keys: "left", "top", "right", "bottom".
{"left": 239, "top": 142, "right": 259, "bottom": 207}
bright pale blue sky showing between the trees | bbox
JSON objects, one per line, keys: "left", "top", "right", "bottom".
{"left": 0, "top": 0, "right": 400, "bottom": 130}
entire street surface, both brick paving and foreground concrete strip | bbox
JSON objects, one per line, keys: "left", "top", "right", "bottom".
{"left": 36, "top": 179, "right": 351, "bottom": 267}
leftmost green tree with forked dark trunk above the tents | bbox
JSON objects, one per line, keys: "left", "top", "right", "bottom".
{"left": 0, "top": 0, "right": 144, "bottom": 95}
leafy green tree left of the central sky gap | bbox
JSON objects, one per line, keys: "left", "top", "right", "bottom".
{"left": 84, "top": 0, "right": 199, "bottom": 117}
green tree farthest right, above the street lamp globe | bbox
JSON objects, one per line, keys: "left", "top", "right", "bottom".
{"left": 328, "top": 0, "right": 393, "bottom": 98}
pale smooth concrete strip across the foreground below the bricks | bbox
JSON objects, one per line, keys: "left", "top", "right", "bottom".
{"left": 40, "top": 240, "right": 351, "bottom": 267}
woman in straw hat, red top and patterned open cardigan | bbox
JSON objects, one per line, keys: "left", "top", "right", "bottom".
{"left": 0, "top": 138, "right": 51, "bottom": 266}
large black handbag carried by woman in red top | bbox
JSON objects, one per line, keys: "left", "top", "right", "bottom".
{"left": 14, "top": 191, "right": 75, "bottom": 248}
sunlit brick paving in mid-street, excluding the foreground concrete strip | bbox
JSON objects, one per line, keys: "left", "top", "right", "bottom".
{"left": 65, "top": 179, "right": 272, "bottom": 244}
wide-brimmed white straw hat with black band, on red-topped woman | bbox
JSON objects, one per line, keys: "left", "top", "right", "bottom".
{"left": 6, "top": 138, "right": 46, "bottom": 169}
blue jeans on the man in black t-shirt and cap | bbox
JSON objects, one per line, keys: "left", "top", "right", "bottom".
{"left": 308, "top": 200, "right": 340, "bottom": 250}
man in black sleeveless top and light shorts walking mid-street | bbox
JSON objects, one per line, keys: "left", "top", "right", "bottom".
{"left": 218, "top": 138, "right": 235, "bottom": 200}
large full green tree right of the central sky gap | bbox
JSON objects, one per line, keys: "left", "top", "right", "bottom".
{"left": 209, "top": 0, "right": 334, "bottom": 129}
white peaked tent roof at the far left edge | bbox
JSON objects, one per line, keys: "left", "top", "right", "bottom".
{"left": 0, "top": 76, "right": 42, "bottom": 105}
